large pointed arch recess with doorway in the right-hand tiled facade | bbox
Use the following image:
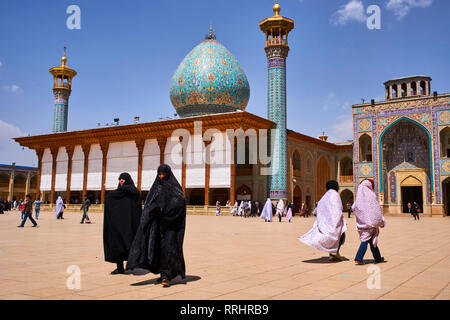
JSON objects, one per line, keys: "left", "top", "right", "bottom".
{"left": 380, "top": 118, "right": 433, "bottom": 212}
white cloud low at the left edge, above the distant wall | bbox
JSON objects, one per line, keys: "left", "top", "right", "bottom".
{"left": 0, "top": 120, "right": 37, "bottom": 166}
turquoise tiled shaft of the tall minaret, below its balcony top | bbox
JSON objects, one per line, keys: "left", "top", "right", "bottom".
{"left": 266, "top": 47, "right": 288, "bottom": 199}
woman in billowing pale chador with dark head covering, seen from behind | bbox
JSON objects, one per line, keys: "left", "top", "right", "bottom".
{"left": 299, "top": 181, "right": 347, "bottom": 261}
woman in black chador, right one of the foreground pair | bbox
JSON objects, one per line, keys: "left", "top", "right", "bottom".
{"left": 127, "top": 164, "right": 186, "bottom": 287}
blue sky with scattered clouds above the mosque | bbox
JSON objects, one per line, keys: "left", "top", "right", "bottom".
{"left": 0, "top": 0, "right": 450, "bottom": 165}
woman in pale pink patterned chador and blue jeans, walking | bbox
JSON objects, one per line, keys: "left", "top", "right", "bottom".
{"left": 352, "top": 179, "right": 386, "bottom": 265}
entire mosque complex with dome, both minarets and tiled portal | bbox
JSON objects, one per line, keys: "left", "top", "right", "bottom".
{"left": 15, "top": 3, "right": 450, "bottom": 216}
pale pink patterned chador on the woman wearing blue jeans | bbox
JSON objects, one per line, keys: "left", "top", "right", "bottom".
{"left": 352, "top": 180, "right": 385, "bottom": 246}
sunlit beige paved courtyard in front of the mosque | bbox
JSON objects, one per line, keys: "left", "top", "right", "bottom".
{"left": 0, "top": 211, "right": 450, "bottom": 300}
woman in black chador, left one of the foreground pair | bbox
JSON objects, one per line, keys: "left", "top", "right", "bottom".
{"left": 103, "top": 173, "right": 142, "bottom": 274}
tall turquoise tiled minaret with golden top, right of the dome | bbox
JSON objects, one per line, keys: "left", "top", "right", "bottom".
{"left": 259, "top": 1, "right": 294, "bottom": 200}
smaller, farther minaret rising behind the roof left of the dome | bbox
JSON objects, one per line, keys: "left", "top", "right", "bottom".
{"left": 49, "top": 47, "right": 77, "bottom": 132}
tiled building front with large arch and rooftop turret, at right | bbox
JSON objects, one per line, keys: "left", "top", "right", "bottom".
{"left": 353, "top": 76, "right": 450, "bottom": 216}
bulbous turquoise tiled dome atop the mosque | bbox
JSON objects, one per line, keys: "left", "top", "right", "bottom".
{"left": 170, "top": 39, "right": 250, "bottom": 117}
